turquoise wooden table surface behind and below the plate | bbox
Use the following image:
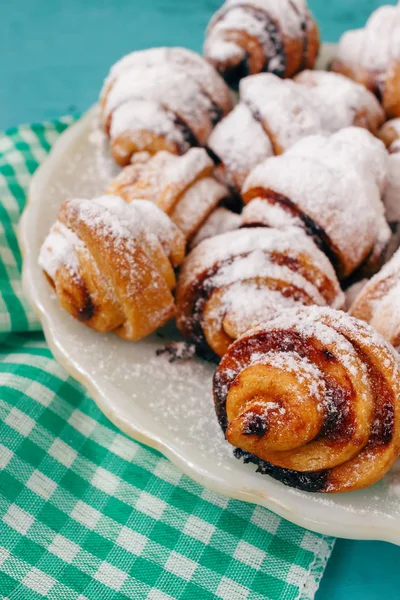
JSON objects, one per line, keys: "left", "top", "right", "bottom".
{"left": 0, "top": 0, "right": 400, "bottom": 600}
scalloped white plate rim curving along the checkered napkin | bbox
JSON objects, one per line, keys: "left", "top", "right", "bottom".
{"left": 17, "top": 96, "right": 400, "bottom": 545}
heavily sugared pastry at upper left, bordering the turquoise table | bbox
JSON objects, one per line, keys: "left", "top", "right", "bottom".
{"left": 100, "top": 48, "right": 232, "bottom": 166}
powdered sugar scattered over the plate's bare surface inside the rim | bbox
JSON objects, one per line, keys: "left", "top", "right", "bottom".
{"left": 32, "top": 110, "right": 400, "bottom": 512}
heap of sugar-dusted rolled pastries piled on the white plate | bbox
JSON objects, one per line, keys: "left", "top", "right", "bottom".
{"left": 39, "top": 0, "right": 400, "bottom": 492}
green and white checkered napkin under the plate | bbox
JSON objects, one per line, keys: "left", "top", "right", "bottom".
{"left": 0, "top": 118, "right": 333, "bottom": 600}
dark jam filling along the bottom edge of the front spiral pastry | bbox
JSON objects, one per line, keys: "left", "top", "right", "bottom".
{"left": 233, "top": 448, "right": 329, "bottom": 493}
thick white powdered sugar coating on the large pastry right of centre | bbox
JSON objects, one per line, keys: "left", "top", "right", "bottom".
{"left": 243, "top": 130, "right": 390, "bottom": 273}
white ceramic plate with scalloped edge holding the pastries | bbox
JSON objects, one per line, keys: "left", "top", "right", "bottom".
{"left": 20, "top": 48, "right": 400, "bottom": 544}
